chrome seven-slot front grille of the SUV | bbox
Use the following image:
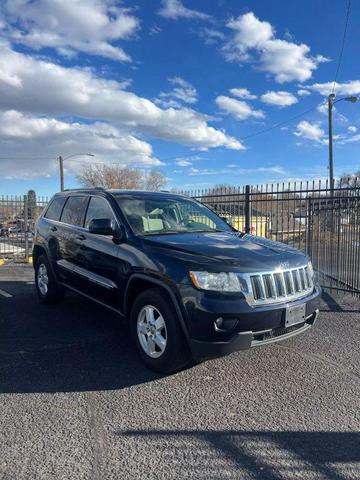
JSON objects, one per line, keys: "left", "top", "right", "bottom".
{"left": 241, "top": 266, "right": 314, "bottom": 305}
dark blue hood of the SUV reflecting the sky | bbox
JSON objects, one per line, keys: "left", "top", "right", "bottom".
{"left": 144, "top": 232, "right": 307, "bottom": 272}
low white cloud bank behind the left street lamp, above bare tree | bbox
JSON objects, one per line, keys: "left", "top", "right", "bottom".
{"left": 0, "top": 110, "right": 162, "bottom": 178}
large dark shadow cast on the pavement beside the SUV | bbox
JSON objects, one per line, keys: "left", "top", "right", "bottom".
{"left": 0, "top": 282, "right": 159, "bottom": 393}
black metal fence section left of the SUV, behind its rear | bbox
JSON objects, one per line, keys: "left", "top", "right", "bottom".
{"left": 0, "top": 195, "right": 49, "bottom": 261}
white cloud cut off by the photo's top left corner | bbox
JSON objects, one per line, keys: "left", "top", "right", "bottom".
{"left": 0, "top": 0, "right": 139, "bottom": 61}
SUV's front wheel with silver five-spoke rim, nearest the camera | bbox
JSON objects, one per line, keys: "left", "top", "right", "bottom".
{"left": 130, "top": 288, "right": 191, "bottom": 373}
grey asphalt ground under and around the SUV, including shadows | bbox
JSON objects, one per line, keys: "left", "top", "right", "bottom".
{"left": 0, "top": 265, "right": 360, "bottom": 480}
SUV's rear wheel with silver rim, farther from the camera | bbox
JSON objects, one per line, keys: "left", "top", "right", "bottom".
{"left": 35, "top": 255, "right": 65, "bottom": 303}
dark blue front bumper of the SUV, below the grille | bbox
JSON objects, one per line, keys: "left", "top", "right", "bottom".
{"left": 180, "top": 287, "right": 320, "bottom": 360}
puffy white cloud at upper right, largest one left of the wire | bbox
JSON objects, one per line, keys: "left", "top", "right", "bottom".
{"left": 223, "top": 12, "right": 327, "bottom": 83}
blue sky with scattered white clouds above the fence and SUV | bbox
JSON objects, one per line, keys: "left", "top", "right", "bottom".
{"left": 0, "top": 0, "right": 360, "bottom": 195}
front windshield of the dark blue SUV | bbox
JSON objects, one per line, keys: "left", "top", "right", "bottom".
{"left": 115, "top": 195, "right": 232, "bottom": 235}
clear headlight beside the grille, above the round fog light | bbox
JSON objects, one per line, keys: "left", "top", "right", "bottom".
{"left": 189, "top": 272, "right": 242, "bottom": 292}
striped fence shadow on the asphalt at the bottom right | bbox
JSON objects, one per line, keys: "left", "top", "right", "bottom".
{"left": 115, "top": 430, "right": 360, "bottom": 480}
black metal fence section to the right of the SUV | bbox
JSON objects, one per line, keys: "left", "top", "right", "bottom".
{"left": 181, "top": 178, "right": 360, "bottom": 293}
